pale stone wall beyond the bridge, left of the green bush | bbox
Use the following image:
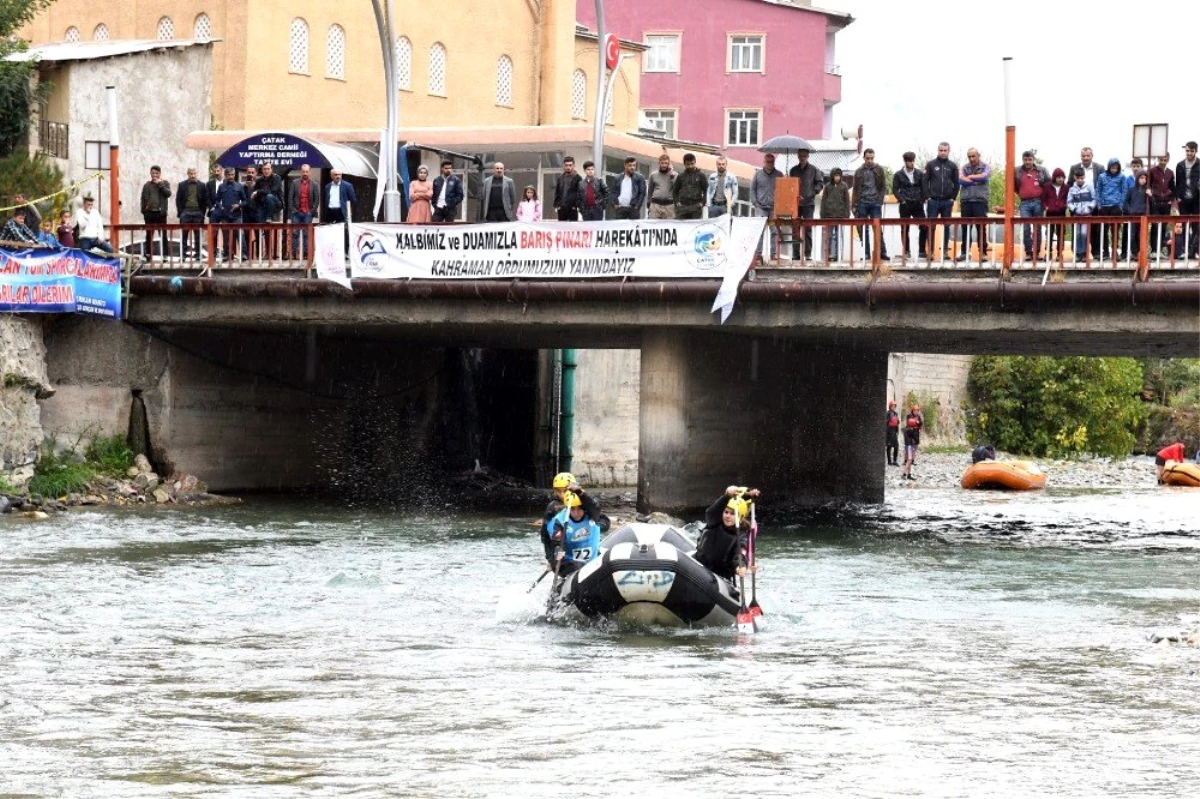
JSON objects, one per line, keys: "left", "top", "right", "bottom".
{"left": 880, "top": 353, "right": 972, "bottom": 445}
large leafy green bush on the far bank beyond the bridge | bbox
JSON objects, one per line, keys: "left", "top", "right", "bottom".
{"left": 967, "top": 356, "right": 1146, "bottom": 457}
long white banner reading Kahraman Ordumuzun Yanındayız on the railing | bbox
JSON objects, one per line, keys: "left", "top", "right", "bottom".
{"left": 350, "top": 216, "right": 763, "bottom": 286}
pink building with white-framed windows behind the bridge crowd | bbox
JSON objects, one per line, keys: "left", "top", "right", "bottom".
{"left": 576, "top": 0, "right": 853, "bottom": 163}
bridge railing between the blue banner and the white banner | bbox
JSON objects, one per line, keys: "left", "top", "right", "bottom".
{"left": 112, "top": 222, "right": 314, "bottom": 274}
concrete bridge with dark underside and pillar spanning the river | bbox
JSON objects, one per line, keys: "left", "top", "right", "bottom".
{"left": 37, "top": 269, "right": 1200, "bottom": 510}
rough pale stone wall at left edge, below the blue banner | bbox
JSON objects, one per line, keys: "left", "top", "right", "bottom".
{"left": 0, "top": 316, "right": 53, "bottom": 485}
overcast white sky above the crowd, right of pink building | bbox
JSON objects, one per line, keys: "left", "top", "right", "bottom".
{"left": 830, "top": 0, "right": 1200, "bottom": 169}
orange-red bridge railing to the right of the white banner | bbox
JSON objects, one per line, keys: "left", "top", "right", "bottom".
{"left": 760, "top": 215, "right": 1200, "bottom": 280}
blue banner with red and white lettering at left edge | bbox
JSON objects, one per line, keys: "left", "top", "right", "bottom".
{"left": 0, "top": 247, "right": 121, "bottom": 319}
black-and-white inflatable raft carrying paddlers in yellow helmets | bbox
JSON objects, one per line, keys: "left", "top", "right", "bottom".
{"left": 551, "top": 523, "right": 740, "bottom": 626}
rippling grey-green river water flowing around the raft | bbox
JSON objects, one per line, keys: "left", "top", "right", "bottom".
{"left": 0, "top": 488, "right": 1200, "bottom": 798}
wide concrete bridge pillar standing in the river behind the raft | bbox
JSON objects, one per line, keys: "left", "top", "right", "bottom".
{"left": 637, "top": 330, "right": 888, "bottom": 512}
